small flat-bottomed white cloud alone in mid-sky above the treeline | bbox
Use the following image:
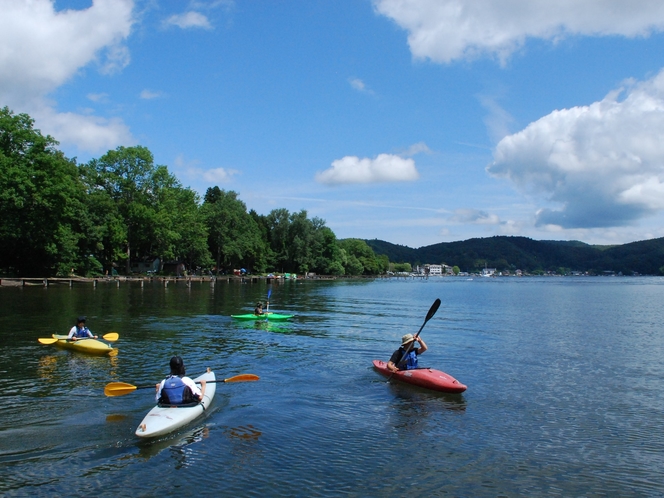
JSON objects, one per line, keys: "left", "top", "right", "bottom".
{"left": 316, "top": 154, "right": 420, "bottom": 185}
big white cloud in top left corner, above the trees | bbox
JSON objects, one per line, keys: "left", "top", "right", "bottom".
{"left": 0, "top": 0, "right": 134, "bottom": 151}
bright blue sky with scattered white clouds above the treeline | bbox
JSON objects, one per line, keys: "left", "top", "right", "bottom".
{"left": 0, "top": 0, "right": 664, "bottom": 247}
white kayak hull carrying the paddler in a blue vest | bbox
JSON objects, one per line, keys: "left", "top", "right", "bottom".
{"left": 136, "top": 368, "right": 217, "bottom": 437}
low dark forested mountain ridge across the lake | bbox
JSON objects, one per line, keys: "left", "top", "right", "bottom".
{"left": 365, "top": 236, "right": 664, "bottom": 275}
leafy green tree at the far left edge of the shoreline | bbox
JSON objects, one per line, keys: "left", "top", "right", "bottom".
{"left": 0, "top": 107, "right": 87, "bottom": 276}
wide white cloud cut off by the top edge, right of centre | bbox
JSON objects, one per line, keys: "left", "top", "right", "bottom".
{"left": 373, "top": 0, "right": 664, "bottom": 63}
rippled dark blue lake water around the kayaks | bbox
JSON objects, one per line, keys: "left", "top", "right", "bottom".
{"left": 0, "top": 277, "right": 664, "bottom": 497}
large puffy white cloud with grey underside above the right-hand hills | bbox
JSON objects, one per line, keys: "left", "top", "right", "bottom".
{"left": 487, "top": 70, "right": 664, "bottom": 228}
